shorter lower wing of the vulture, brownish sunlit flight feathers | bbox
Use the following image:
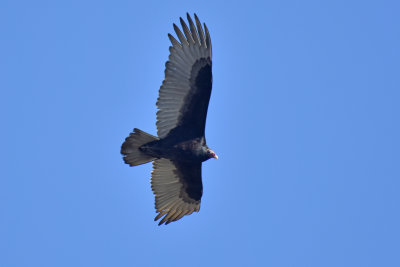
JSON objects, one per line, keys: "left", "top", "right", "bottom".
{"left": 151, "top": 159, "right": 203, "bottom": 225}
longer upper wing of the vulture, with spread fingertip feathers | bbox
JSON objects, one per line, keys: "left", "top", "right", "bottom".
{"left": 156, "top": 14, "right": 212, "bottom": 139}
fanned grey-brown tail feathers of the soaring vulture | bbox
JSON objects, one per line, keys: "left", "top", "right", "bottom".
{"left": 121, "top": 128, "right": 158, "bottom": 166}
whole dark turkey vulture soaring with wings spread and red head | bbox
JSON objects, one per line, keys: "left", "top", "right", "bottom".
{"left": 121, "top": 14, "right": 218, "bottom": 225}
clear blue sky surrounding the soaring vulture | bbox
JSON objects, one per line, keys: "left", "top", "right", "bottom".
{"left": 0, "top": 1, "right": 400, "bottom": 267}
